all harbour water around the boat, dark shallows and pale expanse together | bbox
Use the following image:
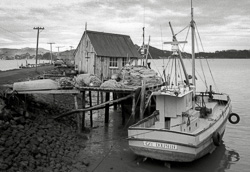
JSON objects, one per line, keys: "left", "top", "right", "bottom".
{"left": 85, "top": 59, "right": 250, "bottom": 172}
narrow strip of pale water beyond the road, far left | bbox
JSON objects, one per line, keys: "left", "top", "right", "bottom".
{"left": 0, "top": 59, "right": 50, "bottom": 71}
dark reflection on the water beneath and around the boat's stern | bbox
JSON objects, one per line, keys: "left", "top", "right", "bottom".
{"left": 84, "top": 108, "right": 240, "bottom": 172}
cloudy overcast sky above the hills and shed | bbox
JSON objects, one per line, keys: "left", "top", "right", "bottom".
{"left": 0, "top": 0, "right": 250, "bottom": 52}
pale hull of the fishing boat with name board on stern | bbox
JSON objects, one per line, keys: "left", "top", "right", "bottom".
{"left": 128, "top": 101, "right": 230, "bottom": 162}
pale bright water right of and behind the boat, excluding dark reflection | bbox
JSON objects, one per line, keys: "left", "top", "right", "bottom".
{"left": 148, "top": 59, "right": 250, "bottom": 172}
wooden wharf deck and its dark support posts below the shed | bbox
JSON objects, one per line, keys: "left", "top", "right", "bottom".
{"left": 12, "top": 85, "right": 162, "bottom": 132}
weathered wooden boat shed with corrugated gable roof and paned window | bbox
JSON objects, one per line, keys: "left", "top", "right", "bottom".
{"left": 74, "top": 30, "right": 140, "bottom": 80}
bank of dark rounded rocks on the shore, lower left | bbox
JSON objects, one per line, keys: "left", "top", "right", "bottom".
{"left": 0, "top": 94, "right": 89, "bottom": 172}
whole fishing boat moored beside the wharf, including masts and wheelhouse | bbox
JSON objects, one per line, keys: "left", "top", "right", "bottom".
{"left": 128, "top": 2, "right": 240, "bottom": 162}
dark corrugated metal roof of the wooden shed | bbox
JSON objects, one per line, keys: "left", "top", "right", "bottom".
{"left": 86, "top": 31, "right": 140, "bottom": 58}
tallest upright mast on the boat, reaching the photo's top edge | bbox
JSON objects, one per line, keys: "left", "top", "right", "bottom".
{"left": 190, "top": 0, "right": 196, "bottom": 90}
